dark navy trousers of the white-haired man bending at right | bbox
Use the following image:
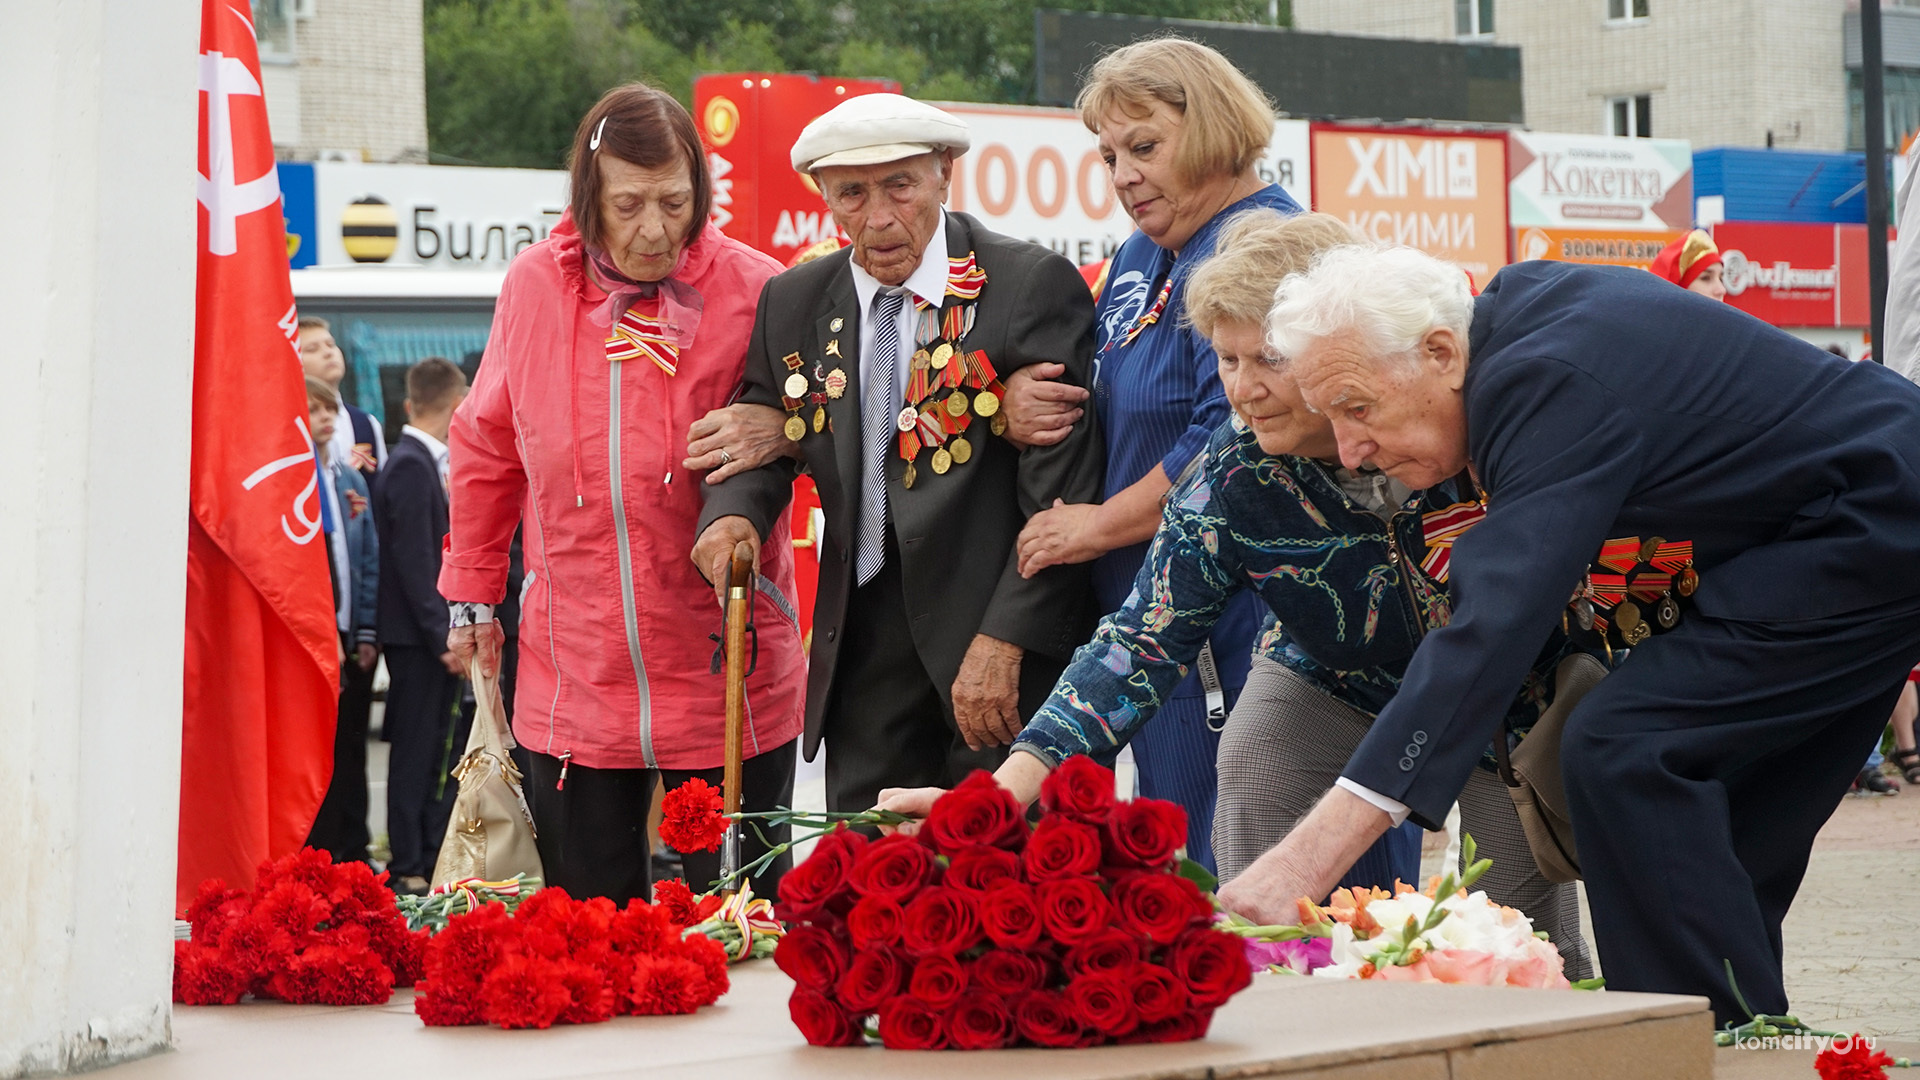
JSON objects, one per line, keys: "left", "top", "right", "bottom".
{"left": 1561, "top": 601, "right": 1920, "bottom": 1022}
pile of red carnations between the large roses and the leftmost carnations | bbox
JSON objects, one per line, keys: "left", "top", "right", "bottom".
{"left": 413, "top": 888, "right": 728, "bottom": 1028}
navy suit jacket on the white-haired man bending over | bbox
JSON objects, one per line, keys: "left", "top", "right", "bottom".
{"left": 1346, "top": 261, "right": 1920, "bottom": 828}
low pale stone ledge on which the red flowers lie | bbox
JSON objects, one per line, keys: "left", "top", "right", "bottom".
{"left": 100, "top": 961, "right": 1715, "bottom": 1080}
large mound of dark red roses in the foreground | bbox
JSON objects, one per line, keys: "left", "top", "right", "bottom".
{"left": 774, "top": 757, "right": 1252, "bottom": 1049}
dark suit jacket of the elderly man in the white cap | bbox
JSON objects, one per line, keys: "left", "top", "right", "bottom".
{"left": 699, "top": 213, "right": 1102, "bottom": 757}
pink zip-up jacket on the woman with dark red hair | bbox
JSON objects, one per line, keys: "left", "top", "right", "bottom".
{"left": 440, "top": 217, "right": 806, "bottom": 769}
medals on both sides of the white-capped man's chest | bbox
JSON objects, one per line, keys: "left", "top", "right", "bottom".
{"left": 781, "top": 319, "right": 1006, "bottom": 488}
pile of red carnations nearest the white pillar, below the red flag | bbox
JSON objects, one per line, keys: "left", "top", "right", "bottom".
{"left": 173, "top": 847, "right": 426, "bottom": 1005}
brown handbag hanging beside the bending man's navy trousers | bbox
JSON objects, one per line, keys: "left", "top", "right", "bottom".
{"left": 1494, "top": 653, "right": 1607, "bottom": 882}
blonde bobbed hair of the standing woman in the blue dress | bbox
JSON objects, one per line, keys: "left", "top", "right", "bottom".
{"left": 1073, "top": 37, "right": 1275, "bottom": 183}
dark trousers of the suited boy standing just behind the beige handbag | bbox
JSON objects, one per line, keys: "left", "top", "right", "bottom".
{"left": 382, "top": 646, "right": 472, "bottom": 878}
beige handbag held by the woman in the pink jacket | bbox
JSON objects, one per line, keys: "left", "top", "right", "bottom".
{"left": 434, "top": 651, "right": 543, "bottom": 888}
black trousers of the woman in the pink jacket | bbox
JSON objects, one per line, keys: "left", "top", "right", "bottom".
{"left": 526, "top": 740, "right": 799, "bottom": 907}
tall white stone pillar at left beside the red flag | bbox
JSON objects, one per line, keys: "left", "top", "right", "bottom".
{"left": 0, "top": 0, "right": 200, "bottom": 1078}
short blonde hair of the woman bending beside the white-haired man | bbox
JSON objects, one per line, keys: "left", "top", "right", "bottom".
{"left": 1187, "top": 208, "right": 1361, "bottom": 336}
